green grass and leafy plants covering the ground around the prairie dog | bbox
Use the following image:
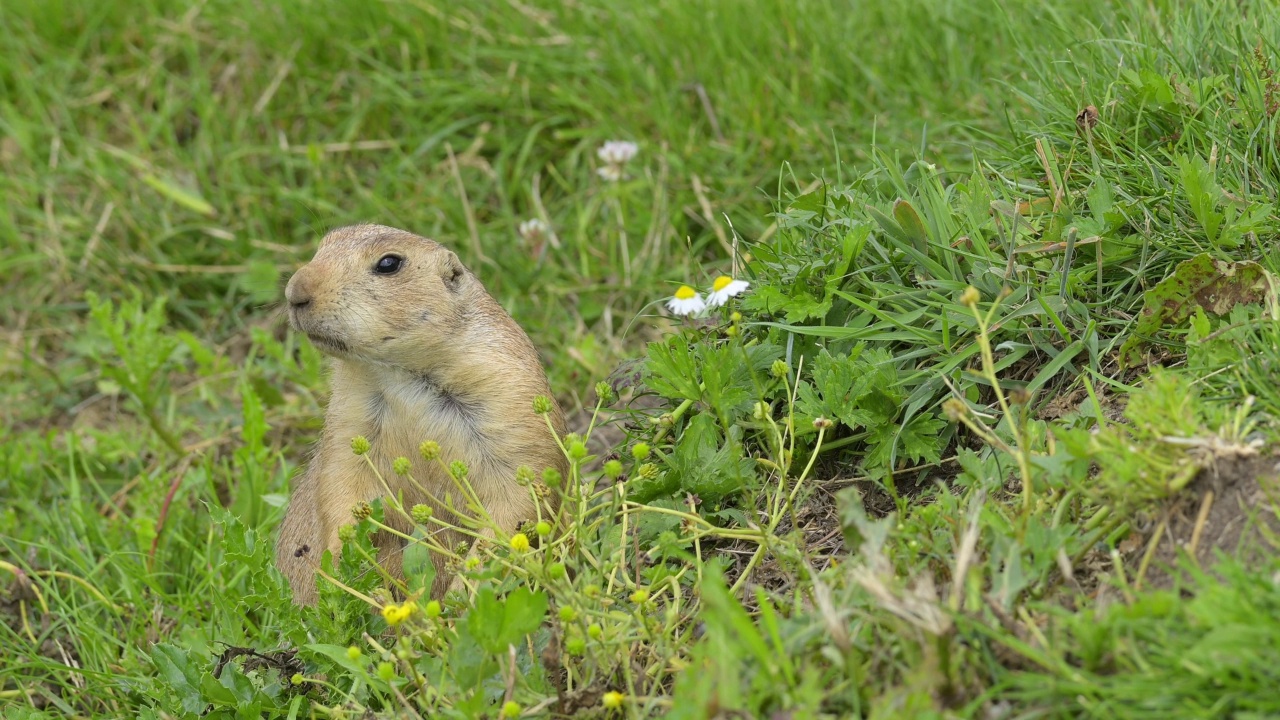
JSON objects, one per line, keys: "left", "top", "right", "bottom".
{"left": 0, "top": 0, "right": 1280, "bottom": 717}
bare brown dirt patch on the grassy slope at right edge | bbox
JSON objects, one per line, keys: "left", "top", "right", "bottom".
{"left": 1144, "top": 455, "right": 1280, "bottom": 588}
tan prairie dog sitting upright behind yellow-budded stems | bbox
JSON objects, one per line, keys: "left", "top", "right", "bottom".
{"left": 276, "top": 225, "right": 568, "bottom": 605}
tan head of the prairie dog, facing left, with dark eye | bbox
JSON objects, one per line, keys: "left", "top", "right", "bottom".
{"left": 284, "top": 225, "right": 476, "bottom": 368}
